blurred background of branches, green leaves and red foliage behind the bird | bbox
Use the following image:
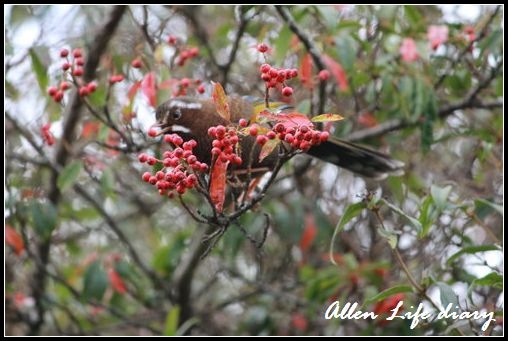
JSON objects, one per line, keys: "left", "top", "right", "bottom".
{"left": 4, "top": 5, "right": 504, "bottom": 335}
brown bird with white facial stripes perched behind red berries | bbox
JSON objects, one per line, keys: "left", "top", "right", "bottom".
{"left": 155, "top": 95, "right": 404, "bottom": 180}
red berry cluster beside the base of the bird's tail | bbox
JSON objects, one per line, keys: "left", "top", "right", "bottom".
{"left": 249, "top": 123, "right": 330, "bottom": 152}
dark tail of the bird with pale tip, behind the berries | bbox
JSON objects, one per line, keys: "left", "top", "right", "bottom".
{"left": 307, "top": 139, "right": 404, "bottom": 179}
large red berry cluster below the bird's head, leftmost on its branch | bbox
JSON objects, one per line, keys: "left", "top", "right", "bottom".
{"left": 138, "top": 134, "right": 208, "bottom": 198}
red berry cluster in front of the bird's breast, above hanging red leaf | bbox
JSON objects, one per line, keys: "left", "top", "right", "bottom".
{"left": 208, "top": 125, "right": 243, "bottom": 166}
